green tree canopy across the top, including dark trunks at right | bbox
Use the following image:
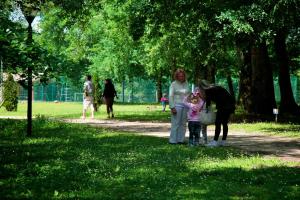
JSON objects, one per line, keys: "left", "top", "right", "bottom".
{"left": 0, "top": 0, "right": 300, "bottom": 114}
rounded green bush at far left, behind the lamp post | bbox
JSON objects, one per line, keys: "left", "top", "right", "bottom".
{"left": 3, "top": 74, "right": 19, "bottom": 111}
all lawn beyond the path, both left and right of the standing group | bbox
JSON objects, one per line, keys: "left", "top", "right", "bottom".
{"left": 0, "top": 102, "right": 300, "bottom": 138}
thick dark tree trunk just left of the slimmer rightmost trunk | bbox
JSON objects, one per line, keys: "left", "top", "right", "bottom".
{"left": 251, "top": 42, "right": 276, "bottom": 114}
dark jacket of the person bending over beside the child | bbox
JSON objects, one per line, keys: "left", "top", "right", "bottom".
{"left": 205, "top": 86, "right": 235, "bottom": 113}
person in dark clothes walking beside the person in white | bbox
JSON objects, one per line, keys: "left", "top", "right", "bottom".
{"left": 102, "top": 79, "right": 118, "bottom": 118}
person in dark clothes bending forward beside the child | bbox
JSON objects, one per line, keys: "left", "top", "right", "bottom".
{"left": 199, "top": 80, "right": 235, "bottom": 147}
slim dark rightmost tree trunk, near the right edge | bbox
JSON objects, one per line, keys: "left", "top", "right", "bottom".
{"left": 274, "top": 30, "right": 300, "bottom": 114}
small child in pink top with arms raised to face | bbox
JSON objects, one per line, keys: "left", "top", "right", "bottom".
{"left": 184, "top": 90, "right": 203, "bottom": 146}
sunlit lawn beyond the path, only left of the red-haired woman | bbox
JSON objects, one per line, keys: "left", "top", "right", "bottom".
{"left": 0, "top": 102, "right": 170, "bottom": 121}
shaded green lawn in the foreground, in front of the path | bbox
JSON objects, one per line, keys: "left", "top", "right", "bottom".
{"left": 0, "top": 118, "right": 300, "bottom": 199}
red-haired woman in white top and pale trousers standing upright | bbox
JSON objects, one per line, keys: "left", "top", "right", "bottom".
{"left": 169, "top": 69, "right": 190, "bottom": 144}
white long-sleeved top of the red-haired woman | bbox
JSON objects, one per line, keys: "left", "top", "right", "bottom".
{"left": 169, "top": 80, "right": 190, "bottom": 108}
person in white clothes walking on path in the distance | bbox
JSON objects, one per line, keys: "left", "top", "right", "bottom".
{"left": 81, "top": 75, "right": 94, "bottom": 119}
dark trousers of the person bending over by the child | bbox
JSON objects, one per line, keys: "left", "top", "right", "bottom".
{"left": 214, "top": 110, "right": 232, "bottom": 141}
